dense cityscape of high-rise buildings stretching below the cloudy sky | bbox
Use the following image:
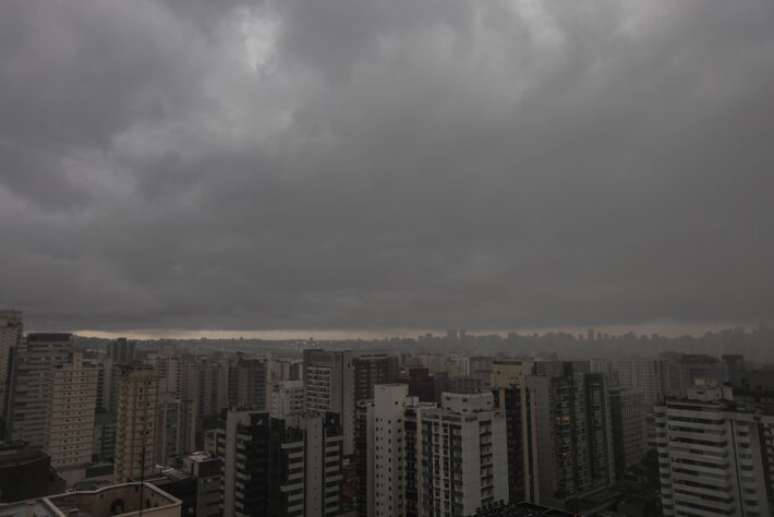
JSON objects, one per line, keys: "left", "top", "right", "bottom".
{"left": 0, "top": 310, "right": 774, "bottom": 517}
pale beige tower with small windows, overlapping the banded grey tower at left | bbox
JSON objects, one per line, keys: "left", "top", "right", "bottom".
{"left": 46, "top": 352, "right": 97, "bottom": 486}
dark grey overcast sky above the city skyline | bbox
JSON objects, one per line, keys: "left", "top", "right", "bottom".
{"left": 0, "top": 0, "right": 774, "bottom": 332}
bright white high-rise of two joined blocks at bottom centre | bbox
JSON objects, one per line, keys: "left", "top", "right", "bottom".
{"left": 358, "top": 384, "right": 508, "bottom": 517}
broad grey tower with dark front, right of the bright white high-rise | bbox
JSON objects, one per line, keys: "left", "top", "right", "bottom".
{"left": 522, "top": 362, "right": 615, "bottom": 508}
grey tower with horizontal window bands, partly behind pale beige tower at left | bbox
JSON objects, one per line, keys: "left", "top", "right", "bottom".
{"left": 8, "top": 334, "right": 74, "bottom": 447}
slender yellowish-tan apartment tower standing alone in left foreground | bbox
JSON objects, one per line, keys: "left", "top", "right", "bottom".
{"left": 113, "top": 365, "right": 159, "bottom": 483}
